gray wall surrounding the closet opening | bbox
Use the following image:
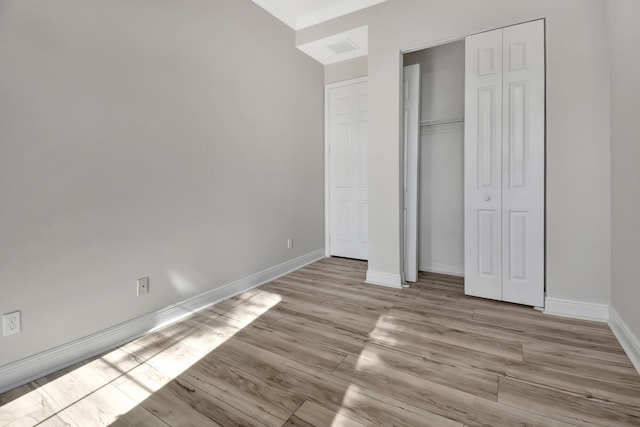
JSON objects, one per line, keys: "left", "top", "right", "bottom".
{"left": 296, "top": 0, "right": 611, "bottom": 304}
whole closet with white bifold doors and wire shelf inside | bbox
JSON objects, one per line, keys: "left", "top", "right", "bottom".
{"left": 404, "top": 20, "right": 545, "bottom": 306}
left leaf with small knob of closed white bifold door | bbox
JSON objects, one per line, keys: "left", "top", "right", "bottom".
{"left": 464, "top": 30, "right": 502, "bottom": 300}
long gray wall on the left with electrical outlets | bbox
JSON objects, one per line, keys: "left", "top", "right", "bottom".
{"left": 0, "top": 0, "right": 324, "bottom": 365}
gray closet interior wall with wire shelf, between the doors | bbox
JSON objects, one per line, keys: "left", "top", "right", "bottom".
{"left": 404, "top": 40, "right": 465, "bottom": 276}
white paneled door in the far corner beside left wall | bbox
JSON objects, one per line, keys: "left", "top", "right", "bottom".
{"left": 328, "top": 82, "right": 369, "bottom": 260}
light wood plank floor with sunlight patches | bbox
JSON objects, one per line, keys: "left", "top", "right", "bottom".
{"left": 0, "top": 258, "right": 640, "bottom": 427}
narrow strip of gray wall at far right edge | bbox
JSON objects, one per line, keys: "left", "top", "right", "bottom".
{"left": 607, "top": 0, "right": 640, "bottom": 340}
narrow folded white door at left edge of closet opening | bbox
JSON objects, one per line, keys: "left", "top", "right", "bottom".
{"left": 404, "top": 64, "right": 420, "bottom": 282}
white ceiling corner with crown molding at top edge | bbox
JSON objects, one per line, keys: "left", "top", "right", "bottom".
{"left": 253, "top": 0, "right": 387, "bottom": 30}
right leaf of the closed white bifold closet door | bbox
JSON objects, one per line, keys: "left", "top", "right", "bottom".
{"left": 502, "top": 21, "right": 545, "bottom": 306}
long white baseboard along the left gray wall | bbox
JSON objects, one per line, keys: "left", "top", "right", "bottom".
{"left": 0, "top": 249, "right": 324, "bottom": 393}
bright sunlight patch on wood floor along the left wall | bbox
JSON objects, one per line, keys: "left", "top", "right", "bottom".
{"left": 0, "top": 291, "right": 281, "bottom": 425}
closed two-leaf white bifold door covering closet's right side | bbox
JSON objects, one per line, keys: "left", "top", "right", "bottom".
{"left": 464, "top": 20, "right": 545, "bottom": 306}
